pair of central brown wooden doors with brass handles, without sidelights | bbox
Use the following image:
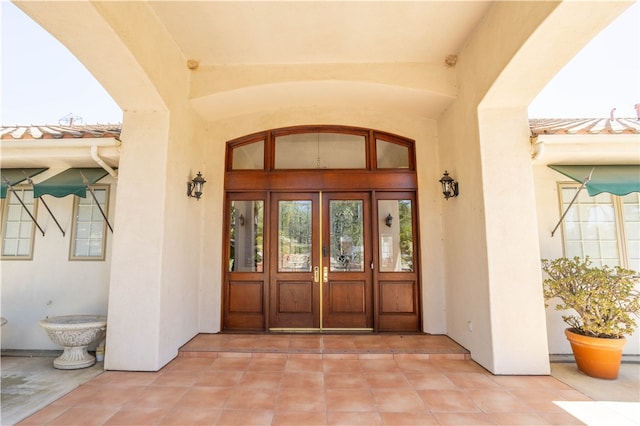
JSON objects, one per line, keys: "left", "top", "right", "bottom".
{"left": 269, "top": 192, "right": 373, "bottom": 330}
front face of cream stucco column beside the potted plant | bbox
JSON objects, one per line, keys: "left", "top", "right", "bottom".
{"left": 479, "top": 108, "right": 549, "bottom": 374}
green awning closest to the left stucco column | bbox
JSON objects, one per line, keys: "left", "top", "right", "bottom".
{"left": 33, "top": 168, "right": 108, "bottom": 198}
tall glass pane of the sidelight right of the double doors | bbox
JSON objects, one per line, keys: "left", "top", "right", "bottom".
{"left": 378, "top": 200, "right": 414, "bottom": 272}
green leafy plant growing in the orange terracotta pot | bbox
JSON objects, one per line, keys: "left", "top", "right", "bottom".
{"left": 542, "top": 257, "right": 640, "bottom": 338}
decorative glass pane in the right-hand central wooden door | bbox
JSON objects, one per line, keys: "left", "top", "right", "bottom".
{"left": 329, "top": 200, "right": 364, "bottom": 272}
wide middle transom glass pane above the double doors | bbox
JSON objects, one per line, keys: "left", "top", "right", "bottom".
{"left": 275, "top": 133, "right": 367, "bottom": 169}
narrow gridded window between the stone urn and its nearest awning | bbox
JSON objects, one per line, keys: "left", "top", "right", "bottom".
{"left": 69, "top": 186, "right": 109, "bottom": 260}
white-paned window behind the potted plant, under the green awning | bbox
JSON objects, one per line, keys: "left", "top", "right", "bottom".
{"left": 559, "top": 183, "right": 640, "bottom": 271}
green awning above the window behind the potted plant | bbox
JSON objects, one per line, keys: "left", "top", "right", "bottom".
{"left": 549, "top": 164, "right": 640, "bottom": 197}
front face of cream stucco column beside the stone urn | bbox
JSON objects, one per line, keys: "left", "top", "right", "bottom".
{"left": 105, "top": 113, "right": 169, "bottom": 371}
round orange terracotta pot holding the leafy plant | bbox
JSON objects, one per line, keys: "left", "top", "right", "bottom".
{"left": 564, "top": 328, "right": 627, "bottom": 380}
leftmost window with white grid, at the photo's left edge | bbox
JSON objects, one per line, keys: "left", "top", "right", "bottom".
{"left": 2, "top": 187, "right": 38, "bottom": 260}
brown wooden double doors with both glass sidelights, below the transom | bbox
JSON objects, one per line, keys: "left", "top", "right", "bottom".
{"left": 223, "top": 191, "right": 419, "bottom": 331}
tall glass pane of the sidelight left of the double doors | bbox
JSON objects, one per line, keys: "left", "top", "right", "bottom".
{"left": 229, "top": 200, "right": 264, "bottom": 272}
